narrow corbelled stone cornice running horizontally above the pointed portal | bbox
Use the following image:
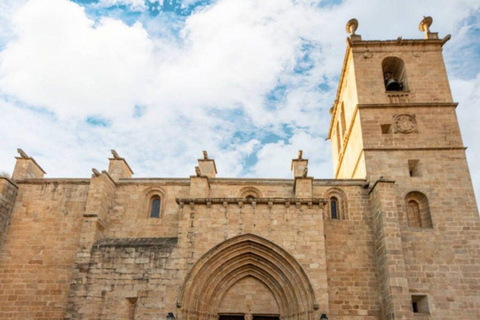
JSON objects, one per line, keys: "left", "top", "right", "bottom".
{"left": 176, "top": 198, "right": 327, "bottom": 207}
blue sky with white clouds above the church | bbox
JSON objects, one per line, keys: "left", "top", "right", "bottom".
{"left": 0, "top": 0, "right": 480, "bottom": 198}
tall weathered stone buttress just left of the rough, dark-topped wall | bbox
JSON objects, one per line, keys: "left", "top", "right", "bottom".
{"left": 65, "top": 169, "right": 116, "bottom": 320}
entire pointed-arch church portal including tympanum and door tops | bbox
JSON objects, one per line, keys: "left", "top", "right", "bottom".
{"left": 179, "top": 234, "right": 316, "bottom": 320}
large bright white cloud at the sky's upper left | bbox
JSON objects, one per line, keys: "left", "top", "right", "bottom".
{"left": 0, "top": 0, "right": 152, "bottom": 118}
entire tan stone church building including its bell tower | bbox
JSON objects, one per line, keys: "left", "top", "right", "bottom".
{"left": 0, "top": 17, "right": 480, "bottom": 320}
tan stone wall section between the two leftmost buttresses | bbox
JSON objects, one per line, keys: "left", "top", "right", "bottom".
{"left": 0, "top": 181, "right": 88, "bottom": 320}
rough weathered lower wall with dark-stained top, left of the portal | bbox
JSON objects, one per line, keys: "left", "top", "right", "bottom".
{"left": 72, "top": 238, "right": 177, "bottom": 320}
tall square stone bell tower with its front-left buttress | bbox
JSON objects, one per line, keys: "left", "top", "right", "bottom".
{"left": 329, "top": 17, "right": 480, "bottom": 319}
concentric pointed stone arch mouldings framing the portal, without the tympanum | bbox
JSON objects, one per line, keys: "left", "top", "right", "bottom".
{"left": 178, "top": 234, "right": 318, "bottom": 320}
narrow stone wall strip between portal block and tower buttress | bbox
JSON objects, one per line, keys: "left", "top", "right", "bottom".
{"left": 325, "top": 188, "right": 381, "bottom": 319}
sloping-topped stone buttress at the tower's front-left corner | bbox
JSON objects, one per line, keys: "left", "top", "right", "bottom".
{"left": 370, "top": 180, "right": 412, "bottom": 320}
